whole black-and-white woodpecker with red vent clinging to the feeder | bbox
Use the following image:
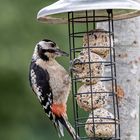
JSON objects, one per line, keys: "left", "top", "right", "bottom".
{"left": 29, "top": 39, "right": 79, "bottom": 140}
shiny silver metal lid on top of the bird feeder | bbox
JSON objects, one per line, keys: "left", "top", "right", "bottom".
{"left": 37, "top": 0, "right": 140, "bottom": 24}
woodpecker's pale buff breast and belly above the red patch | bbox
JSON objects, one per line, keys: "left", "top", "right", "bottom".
{"left": 47, "top": 61, "right": 71, "bottom": 104}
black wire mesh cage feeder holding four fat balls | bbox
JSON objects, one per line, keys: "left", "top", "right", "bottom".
{"left": 68, "top": 10, "right": 120, "bottom": 140}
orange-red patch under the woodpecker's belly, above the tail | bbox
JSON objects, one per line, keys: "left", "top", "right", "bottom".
{"left": 51, "top": 104, "right": 66, "bottom": 117}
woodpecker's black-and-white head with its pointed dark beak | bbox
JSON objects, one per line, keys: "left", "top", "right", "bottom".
{"left": 35, "top": 39, "right": 68, "bottom": 61}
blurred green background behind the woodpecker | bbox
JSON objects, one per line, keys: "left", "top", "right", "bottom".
{"left": 0, "top": 0, "right": 73, "bottom": 140}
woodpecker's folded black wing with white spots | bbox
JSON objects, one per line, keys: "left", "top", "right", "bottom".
{"left": 29, "top": 62, "right": 53, "bottom": 120}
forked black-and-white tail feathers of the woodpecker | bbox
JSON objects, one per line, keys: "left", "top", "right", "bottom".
{"left": 56, "top": 116, "right": 80, "bottom": 140}
